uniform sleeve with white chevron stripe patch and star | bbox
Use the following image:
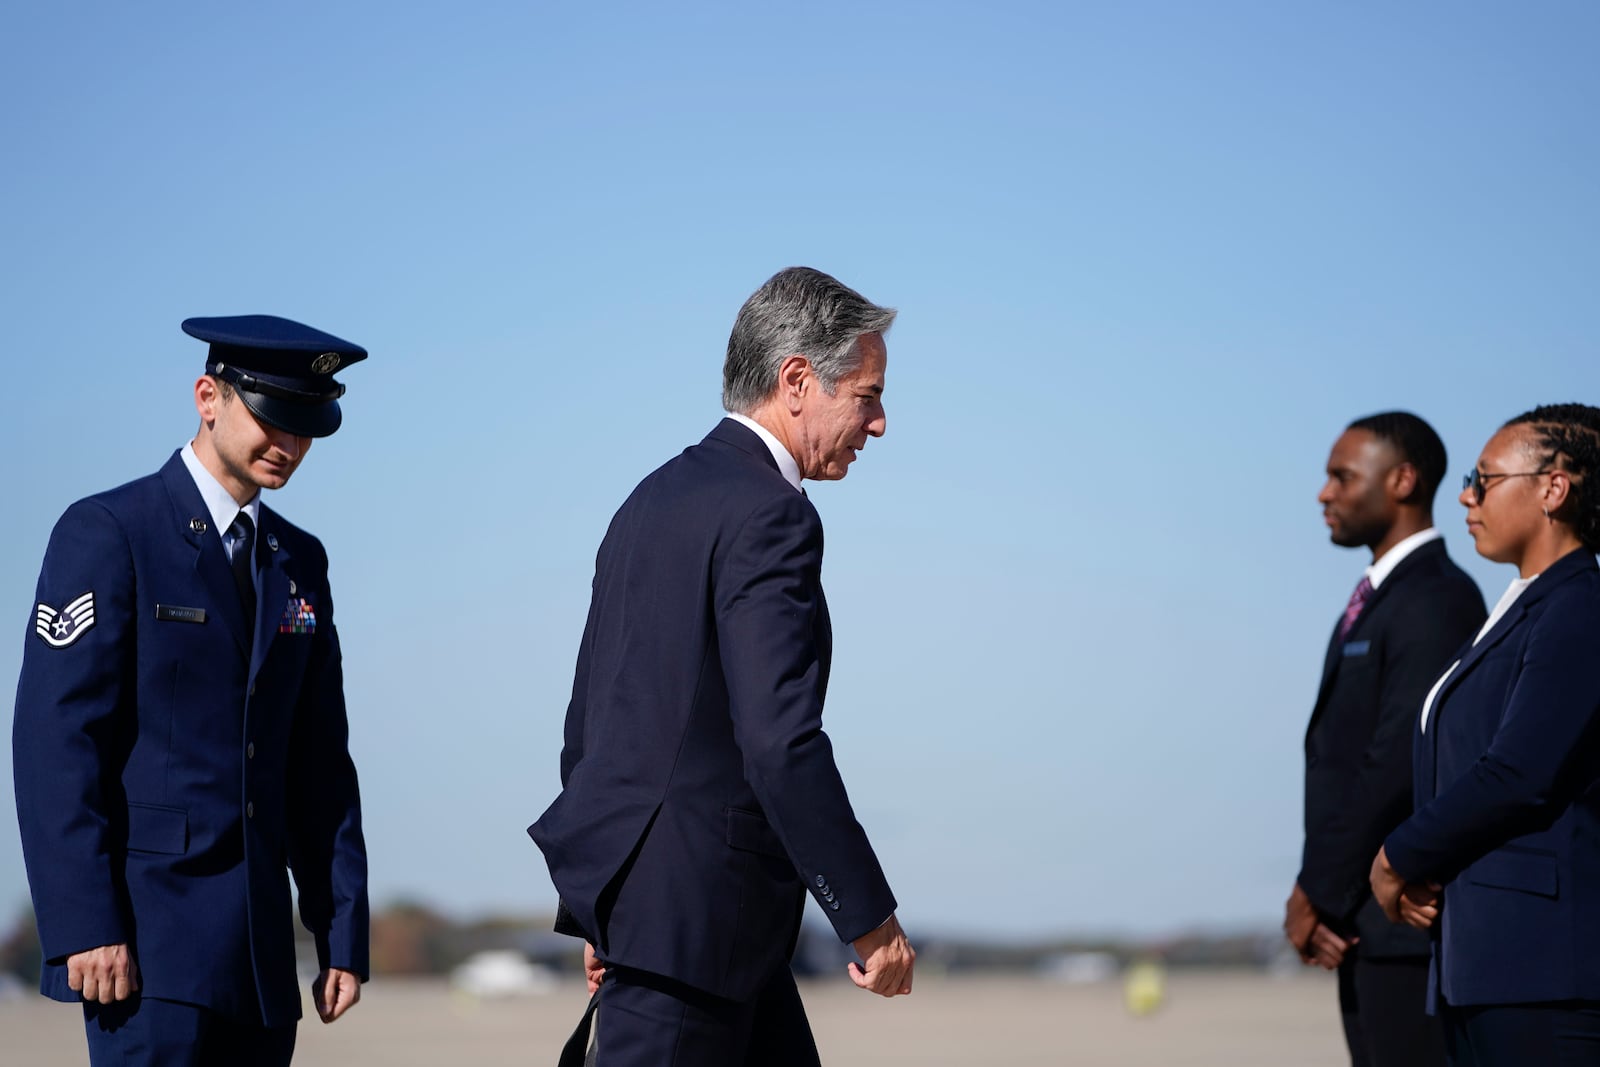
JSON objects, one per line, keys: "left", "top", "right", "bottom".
{"left": 11, "top": 501, "right": 136, "bottom": 965}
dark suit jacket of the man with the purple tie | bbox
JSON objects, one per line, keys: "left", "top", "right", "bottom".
{"left": 1299, "top": 541, "right": 1486, "bottom": 958}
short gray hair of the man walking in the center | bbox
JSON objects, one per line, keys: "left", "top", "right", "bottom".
{"left": 722, "top": 267, "right": 896, "bottom": 414}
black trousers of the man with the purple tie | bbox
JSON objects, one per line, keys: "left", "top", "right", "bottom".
{"left": 1339, "top": 950, "right": 1445, "bottom": 1067}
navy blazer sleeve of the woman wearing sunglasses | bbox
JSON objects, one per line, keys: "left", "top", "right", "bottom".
{"left": 1384, "top": 590, "right": 1600, "bottom": 881}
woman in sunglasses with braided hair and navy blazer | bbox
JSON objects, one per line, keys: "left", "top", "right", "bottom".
{"left": 1373, "top": 403, "right": 1600, "bottom": 1067}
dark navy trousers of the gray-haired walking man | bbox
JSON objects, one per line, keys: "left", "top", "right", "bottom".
{"left": 594, "top": 966, "right": 821, "bottom": 1067}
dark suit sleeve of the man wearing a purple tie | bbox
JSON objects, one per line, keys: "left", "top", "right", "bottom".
{"left": 1299, "top": 595, "right": 1482, "bottom": 921}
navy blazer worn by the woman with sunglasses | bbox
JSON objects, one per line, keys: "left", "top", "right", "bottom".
{"left": 1384, "top": 550, "right": 1600, "bottom": 1006}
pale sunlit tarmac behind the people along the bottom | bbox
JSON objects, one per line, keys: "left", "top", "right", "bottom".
{"left": 0, "top": 971, "right": 1349, "bottom": 1067}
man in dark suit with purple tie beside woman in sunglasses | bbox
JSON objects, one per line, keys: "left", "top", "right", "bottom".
{"left": 1283, "top": 411, "right": 1485, "bottom": 1067}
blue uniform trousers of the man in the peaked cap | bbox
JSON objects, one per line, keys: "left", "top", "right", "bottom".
{"left": 83, "top": 993, "right": 294, "bottom": 1067}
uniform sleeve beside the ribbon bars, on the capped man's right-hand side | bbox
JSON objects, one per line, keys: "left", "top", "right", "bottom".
{"left": 290, "top": 545, "right": 370, "bottom": 979}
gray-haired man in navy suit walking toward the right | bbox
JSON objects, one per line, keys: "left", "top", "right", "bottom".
{"left": 528, "top": 267, "right": 915, "bottom": 1067}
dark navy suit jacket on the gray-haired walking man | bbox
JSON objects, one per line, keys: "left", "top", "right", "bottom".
{"left": 528, "top": 419, "right": 894, "bottom": 1000}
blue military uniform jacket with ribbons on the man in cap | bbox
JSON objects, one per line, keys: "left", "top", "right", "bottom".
{"left": 11, "top": 454, "right": 368, "bottom": 1025}
